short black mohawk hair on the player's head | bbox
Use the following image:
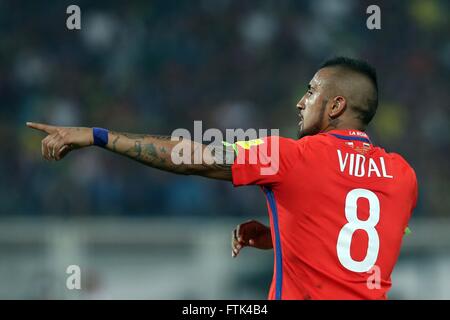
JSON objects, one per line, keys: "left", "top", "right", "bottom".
{"left": 319, "top": 57, "right": 378, "bottom": 125}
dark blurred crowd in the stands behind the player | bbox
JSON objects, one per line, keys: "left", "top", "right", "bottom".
{"left": 0, "top": 0, "right": 450, "bottom": 217}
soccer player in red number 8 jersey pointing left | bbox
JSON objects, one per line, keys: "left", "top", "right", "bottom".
{"left": 27, "top": 57, "right": 417, "bottom": 299}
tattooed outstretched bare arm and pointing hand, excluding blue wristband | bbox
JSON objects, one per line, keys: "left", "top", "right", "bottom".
{"left": 27, "top": 122, "right": 234, "bottom": 180}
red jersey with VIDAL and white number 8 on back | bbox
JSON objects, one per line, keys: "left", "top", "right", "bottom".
{"left": 232, "top": 130, "right": 417, "bottom": 299}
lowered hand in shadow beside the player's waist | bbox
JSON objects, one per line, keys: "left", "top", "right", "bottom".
{"left": 231, "top": 220, "right": 273, "bottom": 258}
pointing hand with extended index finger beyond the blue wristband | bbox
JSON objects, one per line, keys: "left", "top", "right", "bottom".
{"left": 27, "top": 122, "right": 94, "bottom": 160}
